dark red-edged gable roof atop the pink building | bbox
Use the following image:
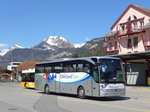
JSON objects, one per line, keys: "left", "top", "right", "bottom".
{"left": 111, "top": 4, "right": 150, "bottom": 29}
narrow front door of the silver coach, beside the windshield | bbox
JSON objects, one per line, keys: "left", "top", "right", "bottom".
{"left": 92, "top": 66, "right": 100, "bottom": 97}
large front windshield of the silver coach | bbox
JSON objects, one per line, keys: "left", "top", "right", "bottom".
{"left": 99, "top": 59, "right": 125, "bottom": 83}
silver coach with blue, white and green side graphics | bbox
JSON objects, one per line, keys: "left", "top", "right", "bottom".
{"left": 35, "top": 57, "right": 125, "bottom": 98}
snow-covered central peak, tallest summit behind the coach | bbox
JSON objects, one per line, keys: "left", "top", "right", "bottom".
{"left": 33, "top": 36, "right": 74, "bottom": 50}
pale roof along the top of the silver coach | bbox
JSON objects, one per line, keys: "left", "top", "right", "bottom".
{"left": 34, "top": 56, "right": 120, "bottom": 65}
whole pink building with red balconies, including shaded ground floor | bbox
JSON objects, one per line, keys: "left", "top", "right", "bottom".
{"left": 104, "top": 4, "right": 150, "bottom": 86}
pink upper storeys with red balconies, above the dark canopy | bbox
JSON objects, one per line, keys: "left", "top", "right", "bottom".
{"left": 104, "top": 5, "right": 150, "bottom": 55}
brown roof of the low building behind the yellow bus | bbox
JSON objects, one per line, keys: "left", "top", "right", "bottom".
{"left": 17, "top": 61, "right": 40, "bottom": 72}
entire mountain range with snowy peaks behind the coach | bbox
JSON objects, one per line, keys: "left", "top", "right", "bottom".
{"left": 0, "top": 36, "right": 103, "bottom": 66}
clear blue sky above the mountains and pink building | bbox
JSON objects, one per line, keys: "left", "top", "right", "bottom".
{"left": 0, "top": 0, "right": 150, "bottom": 49}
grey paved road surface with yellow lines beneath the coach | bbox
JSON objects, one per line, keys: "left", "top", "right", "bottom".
{"left": 0, "top": 83, "right": 150, "bottom": 112}
